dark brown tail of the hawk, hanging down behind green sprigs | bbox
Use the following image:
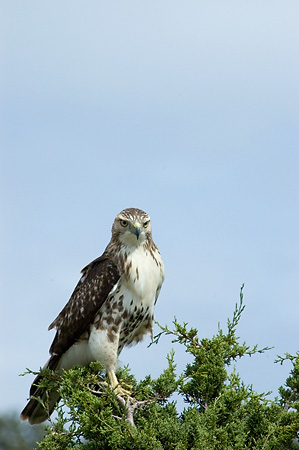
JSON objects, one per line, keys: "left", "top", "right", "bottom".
{"left": 21, "top": 355, "right": 60, "bottom": 425}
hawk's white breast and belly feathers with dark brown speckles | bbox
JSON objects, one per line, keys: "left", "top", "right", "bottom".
{"left": 60, "top": 245, "right": 164, "bottom": 370}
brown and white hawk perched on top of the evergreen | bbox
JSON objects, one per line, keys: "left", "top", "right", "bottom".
{"left": 21, "top": 208, "right": 164, "bottom": 424}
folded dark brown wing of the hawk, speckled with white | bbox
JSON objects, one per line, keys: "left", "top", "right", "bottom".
{"left": 49, "top": 253, "right": 120, "bottom": 355}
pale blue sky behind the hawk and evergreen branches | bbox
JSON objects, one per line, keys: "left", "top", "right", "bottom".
{"left": 0, "top": 0, "right": 299, "bottom": 411}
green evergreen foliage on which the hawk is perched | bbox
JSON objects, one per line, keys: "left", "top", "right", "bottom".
{"left": 21, "top": 287, "right": 299, "bottom": 450}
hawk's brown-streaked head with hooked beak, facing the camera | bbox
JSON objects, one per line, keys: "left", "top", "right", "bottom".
{"left": 112, "top": 208, "right": 152, "bottom": 246}
